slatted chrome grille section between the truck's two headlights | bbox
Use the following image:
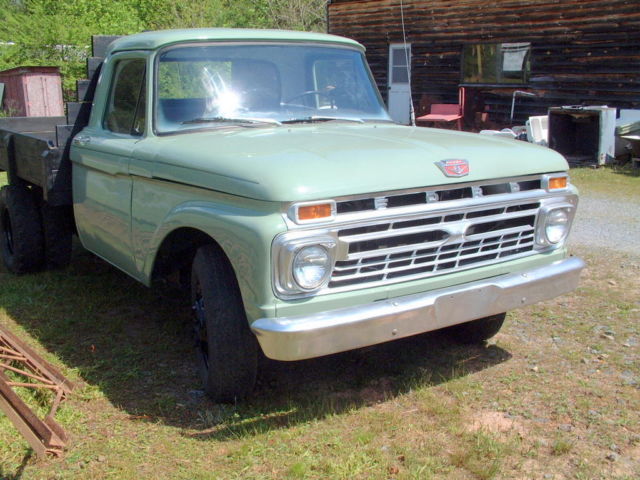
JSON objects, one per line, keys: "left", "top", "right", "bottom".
{"left": 328, "top": 201, "right": 540, "bottom": 290}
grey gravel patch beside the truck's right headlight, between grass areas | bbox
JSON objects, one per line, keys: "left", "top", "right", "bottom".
{"left": 569, "top": 191, "right": 640, "bottom": 255}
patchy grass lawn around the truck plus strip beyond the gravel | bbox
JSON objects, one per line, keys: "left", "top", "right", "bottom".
{"left": 0, "top": 169, "right": 640, "bottom": 480}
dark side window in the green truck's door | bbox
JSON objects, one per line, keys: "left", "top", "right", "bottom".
{"left": 104, "top": 59, "right": 146, "bottom": 136}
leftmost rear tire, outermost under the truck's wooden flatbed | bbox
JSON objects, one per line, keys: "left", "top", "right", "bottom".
{"left": 0, "top": 185, "right": 44, "bottom": 274}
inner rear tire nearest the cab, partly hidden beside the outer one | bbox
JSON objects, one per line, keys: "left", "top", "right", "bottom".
{"left": 40, "top": 202, "right": 72, "bottom": 270}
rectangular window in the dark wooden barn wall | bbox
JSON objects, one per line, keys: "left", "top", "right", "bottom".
{"left": 462, "top": 43, "right": 531, "bottom": 85}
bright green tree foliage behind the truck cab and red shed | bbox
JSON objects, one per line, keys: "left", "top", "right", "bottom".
{"left": 0, "top": 0, "right": 326, "bottom": 98}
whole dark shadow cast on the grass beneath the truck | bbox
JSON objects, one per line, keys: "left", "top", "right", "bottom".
{"left": 0, "top": 249, "right": 510, "bottom": 440}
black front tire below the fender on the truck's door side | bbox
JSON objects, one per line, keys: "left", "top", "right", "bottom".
{"left": 191, "top": 245, "right": 259, "bottom": 403}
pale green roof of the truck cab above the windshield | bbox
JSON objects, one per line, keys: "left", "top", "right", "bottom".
{"left": 108, "top": 28, "right": 364, "bottom": 53}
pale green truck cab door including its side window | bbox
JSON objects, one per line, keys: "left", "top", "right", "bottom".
{"left": 71, "top": 53, "right": 147, "bottom": 276}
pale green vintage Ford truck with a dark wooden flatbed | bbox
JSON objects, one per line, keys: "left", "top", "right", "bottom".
{"left": 0, "top": 29, "right": 584, "bottom": 401}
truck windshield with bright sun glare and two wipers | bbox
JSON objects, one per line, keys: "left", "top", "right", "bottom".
{"left": 155, "top": 43, "right": 390, "bottom": 133}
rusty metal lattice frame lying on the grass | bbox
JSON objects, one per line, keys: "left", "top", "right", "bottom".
{"left": 0, "top": 325, "right": 74, "bottom": 456}
